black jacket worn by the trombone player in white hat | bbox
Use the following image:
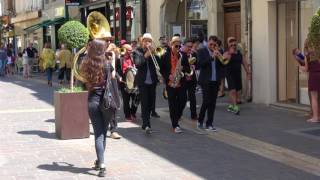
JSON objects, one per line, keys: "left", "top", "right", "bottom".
{"left": 132, "top": 48, "right": 160, "bottom": 86}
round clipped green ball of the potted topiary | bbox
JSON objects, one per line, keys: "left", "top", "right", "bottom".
{"left": 58, "top": 21, "right": 89, "bottom": 49}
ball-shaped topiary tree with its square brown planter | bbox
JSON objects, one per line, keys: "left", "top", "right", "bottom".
{"left": 54, "top": 21, "right": 90, "bottom": 139}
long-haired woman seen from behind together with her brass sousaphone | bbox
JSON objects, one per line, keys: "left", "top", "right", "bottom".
{"left": 74, "top": 12, "right": 120, "bottom": 177}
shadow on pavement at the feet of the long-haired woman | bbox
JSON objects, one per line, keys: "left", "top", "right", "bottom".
{"left": 37, "top": 162, "right": 96, "bottom": 175}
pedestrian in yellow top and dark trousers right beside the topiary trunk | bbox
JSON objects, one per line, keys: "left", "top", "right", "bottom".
{"left": 57, "top": 44, "right": 73, "bottom": 84}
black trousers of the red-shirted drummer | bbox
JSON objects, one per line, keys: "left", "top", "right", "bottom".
{"left": 121, "top": 88, "right": 139, "bottom": 119}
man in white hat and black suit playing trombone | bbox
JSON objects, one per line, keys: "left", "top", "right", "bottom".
{"left": 133, "top": 33, "right": 159, "bottom": 134}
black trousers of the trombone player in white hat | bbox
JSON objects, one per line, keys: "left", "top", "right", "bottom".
{"left": 139, "top": 84, "right": 156, "bottom": 129}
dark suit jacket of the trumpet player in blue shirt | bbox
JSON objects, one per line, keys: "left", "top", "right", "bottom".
{"left": 197, "top": 47, "right": 223, "bottom": 85}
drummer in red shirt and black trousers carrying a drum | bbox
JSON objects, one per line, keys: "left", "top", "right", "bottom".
{"left": 116, "top": 44, "right": 139, "bottom": 121}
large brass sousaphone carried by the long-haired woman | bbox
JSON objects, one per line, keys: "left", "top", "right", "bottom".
{"left": 73, "top": 11, "right": 112, "bottom": 82}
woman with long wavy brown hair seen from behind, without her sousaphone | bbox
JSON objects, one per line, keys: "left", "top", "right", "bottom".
{"left": 80, "top": 39, "right": 116, "bottom": 177}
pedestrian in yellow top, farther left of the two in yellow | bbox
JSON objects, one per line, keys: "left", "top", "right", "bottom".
{"left": 40, "top": 43, "right": 56, "bottom": 87}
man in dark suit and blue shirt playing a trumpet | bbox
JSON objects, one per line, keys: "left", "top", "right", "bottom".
{"left": 197, "top": 36, "right": 223, "bottom": 131}
